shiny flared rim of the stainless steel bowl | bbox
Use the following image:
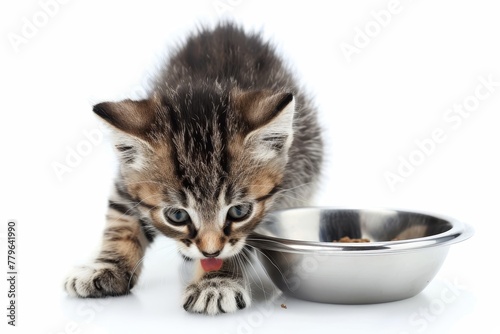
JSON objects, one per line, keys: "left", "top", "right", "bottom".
{"left": 247, "top": 206, "right": 474, "bottom": 256}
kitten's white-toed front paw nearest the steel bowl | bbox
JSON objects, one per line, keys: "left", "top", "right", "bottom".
{"left": 183, "top": 277, "right": 251, "bottom": 315}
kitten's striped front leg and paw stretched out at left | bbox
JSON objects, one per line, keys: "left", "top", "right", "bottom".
{"left": 65, "top": 190, "right": 153, "bottom": 298}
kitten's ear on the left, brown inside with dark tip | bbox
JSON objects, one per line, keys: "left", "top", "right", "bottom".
{"left": 93, "top": 100, "right": 155, "bottom": 138}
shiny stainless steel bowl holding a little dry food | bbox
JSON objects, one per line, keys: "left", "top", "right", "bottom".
{"left": 248, "top": 208, "right": 473, "bottom": 304}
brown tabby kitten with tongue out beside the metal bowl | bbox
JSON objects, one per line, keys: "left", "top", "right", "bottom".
{"left": 65, "top": 23, "right": 323, "bottom": 314}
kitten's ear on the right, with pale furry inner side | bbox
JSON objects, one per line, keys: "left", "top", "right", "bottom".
{"left": 238, "top": 91, "right": 295, "bottom": 161}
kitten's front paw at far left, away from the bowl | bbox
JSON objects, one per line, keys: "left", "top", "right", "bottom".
{"left": 64, "top": 263, "right": 133, "bottom": 298}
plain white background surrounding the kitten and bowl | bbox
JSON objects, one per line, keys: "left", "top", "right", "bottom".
{"left": 0, "top": 0, "right": 500, "bottom": 334}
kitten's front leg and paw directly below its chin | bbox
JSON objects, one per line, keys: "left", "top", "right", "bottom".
{"left": 183, "top": 254, "right": 251, "bottom": 315}
